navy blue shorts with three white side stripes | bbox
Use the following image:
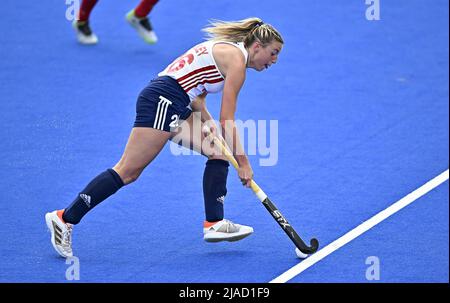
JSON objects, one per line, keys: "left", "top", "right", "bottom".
{"left": 134, "top": 76, "right": 192, "bottom": 132}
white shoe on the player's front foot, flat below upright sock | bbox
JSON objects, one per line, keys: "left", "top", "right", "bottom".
{"left": 203, "top": 219, "right": 253, "bottom": 242}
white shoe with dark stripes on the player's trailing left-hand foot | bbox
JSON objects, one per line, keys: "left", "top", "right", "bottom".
{"left": 45, "top": 210, "right": 73, "bottom": 258}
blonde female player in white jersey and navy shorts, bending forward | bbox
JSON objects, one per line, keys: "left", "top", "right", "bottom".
{"left": 45, "top": 18, "right": 284, "bottom": 257}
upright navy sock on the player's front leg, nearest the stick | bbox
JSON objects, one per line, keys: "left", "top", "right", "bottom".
{"left": 203, "top": 159, "right": 229, "bottom": 222}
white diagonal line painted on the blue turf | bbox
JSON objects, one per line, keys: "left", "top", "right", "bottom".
{"left": 270, "top": 169, "right": 448, "bottom": 283}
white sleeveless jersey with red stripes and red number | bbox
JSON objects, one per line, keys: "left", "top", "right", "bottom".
{"left": 158, "top": 41, "right": 248, "bottom": 101}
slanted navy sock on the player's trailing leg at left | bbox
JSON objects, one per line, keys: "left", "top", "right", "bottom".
{"left": 62, "top": 168, "right": 124, "bottom": 224}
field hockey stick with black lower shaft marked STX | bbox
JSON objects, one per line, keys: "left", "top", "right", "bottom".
{"left": 203, "top": 125, "right": 319, "bottom": 254}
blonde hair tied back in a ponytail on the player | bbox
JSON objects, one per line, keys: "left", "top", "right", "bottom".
{"left": 202, "top": 17, "right": 284, "bottom": 47}
